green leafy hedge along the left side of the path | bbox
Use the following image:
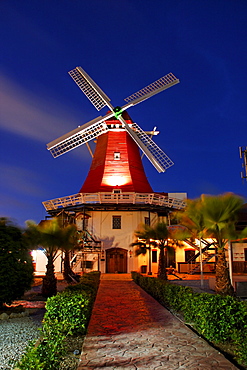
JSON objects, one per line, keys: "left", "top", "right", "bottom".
{"left": 15, "top": 272, "right": 100, "bottom": 370}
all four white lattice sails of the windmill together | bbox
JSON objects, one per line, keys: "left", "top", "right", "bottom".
{"left": 47, "top": 67, "right": 179, "bottom": 172}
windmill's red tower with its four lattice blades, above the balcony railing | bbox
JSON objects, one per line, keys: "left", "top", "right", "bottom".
{"left": 47, "top": 67, "right": 179, "bottom": 193}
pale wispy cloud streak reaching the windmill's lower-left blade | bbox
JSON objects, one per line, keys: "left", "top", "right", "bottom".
{"left": 0, "top": 73, "right": 81, "bottom": 143}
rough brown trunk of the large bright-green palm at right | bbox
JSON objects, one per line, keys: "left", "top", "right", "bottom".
{"left": 215, "top": 249, "right": 234, "bottom": 296}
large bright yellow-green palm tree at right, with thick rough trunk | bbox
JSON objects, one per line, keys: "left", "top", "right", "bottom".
{"left": 177, "top": 193, "right": 243, "bottom": 295}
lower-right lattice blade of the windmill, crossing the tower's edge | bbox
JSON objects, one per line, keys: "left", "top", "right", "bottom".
{"left": 132, "top": 123, "right": 174, "bottom": 172}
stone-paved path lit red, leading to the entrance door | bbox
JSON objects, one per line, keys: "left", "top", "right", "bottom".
{"left": 78, "top": 275, "right": 237, "bottom": 370}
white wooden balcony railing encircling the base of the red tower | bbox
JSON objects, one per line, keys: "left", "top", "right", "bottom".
{"left": 42, "top": 193, "right": 185, "bottom": 211}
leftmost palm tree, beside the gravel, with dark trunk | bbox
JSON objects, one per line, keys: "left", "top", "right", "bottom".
{"left": 25, "top": 218, "right": 76, "bottom": 297}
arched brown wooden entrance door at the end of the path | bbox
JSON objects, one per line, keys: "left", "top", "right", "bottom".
{"left": 106, "top": 248, "right": 127, "bottom": 273}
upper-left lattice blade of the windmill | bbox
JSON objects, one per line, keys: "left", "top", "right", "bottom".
{"left": 68, "top": 67, "right": 112, "bottom": 111}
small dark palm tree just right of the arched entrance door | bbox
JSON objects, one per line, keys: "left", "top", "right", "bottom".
{"left": 131, "top": 222, "right": 175, "bottom": 280}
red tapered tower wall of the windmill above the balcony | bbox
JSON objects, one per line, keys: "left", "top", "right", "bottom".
{"left": 80, "top": 120, "right": 153, "bottom": 193}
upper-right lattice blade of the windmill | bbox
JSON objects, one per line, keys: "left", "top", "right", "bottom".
{"left": 124, "top": 73, "right": 179, "bottom": 105}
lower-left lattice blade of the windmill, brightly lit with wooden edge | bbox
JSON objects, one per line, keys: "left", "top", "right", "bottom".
{"left": 47, "top": 113, "right": 110, "bottom": 158}
